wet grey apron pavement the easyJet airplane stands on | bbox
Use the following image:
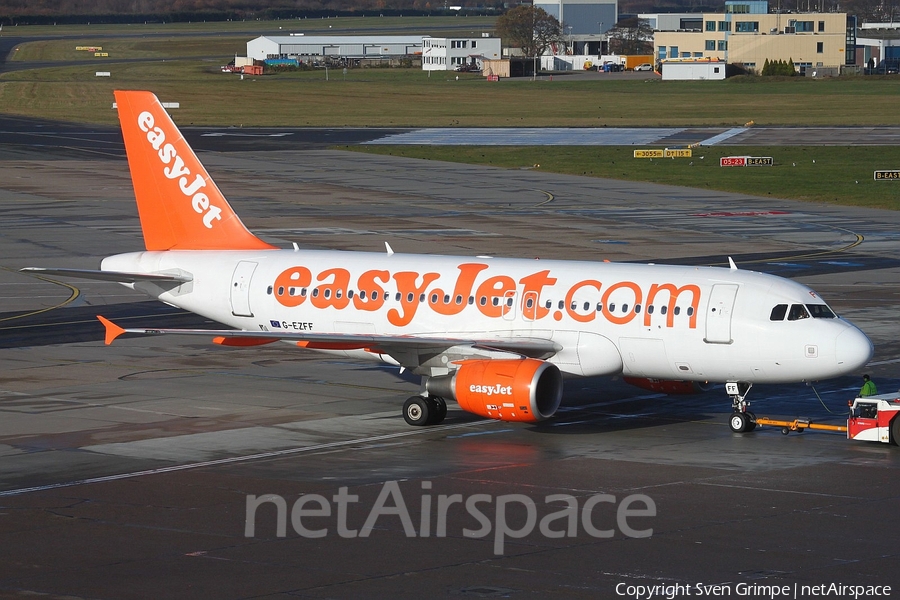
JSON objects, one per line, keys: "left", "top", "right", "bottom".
{"left": 0, "top": 143, "right": 900, "bottom": 599}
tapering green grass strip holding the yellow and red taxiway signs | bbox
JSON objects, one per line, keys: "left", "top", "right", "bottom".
{"left": 342, "top": 146, "right": 900, "bottom": 210}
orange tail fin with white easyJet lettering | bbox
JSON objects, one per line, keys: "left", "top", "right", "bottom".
{"left": 115, "top": 90, "right": 274, "bottom": 250}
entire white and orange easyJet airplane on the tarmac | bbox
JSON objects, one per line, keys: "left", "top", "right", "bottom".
{"left": 24, "top": 91, "right": 873, "bottom": 432}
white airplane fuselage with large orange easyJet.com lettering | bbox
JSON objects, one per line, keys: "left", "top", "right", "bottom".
{"left": 102, "top": 250, "right": 872, "bottom": 383}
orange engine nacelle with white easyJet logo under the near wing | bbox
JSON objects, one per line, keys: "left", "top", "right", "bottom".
{"left": 426, "top": 358, "right": 563, "bottom": 423}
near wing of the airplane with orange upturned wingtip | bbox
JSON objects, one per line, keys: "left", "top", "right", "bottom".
{"left": 97, "top": 315, "right": 562, "bottom": 368}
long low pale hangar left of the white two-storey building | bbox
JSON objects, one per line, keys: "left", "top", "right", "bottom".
{"left": 247, "top": 33, "right": 423, "bottom": 62}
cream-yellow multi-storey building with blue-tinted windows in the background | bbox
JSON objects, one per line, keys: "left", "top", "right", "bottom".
{"left": 654, "top": 0, "right": 856, "bottom": 74}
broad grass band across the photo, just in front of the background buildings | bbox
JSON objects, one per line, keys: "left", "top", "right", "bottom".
{"left": 0, "top": 63, "right": 900, "bottom": 127}
